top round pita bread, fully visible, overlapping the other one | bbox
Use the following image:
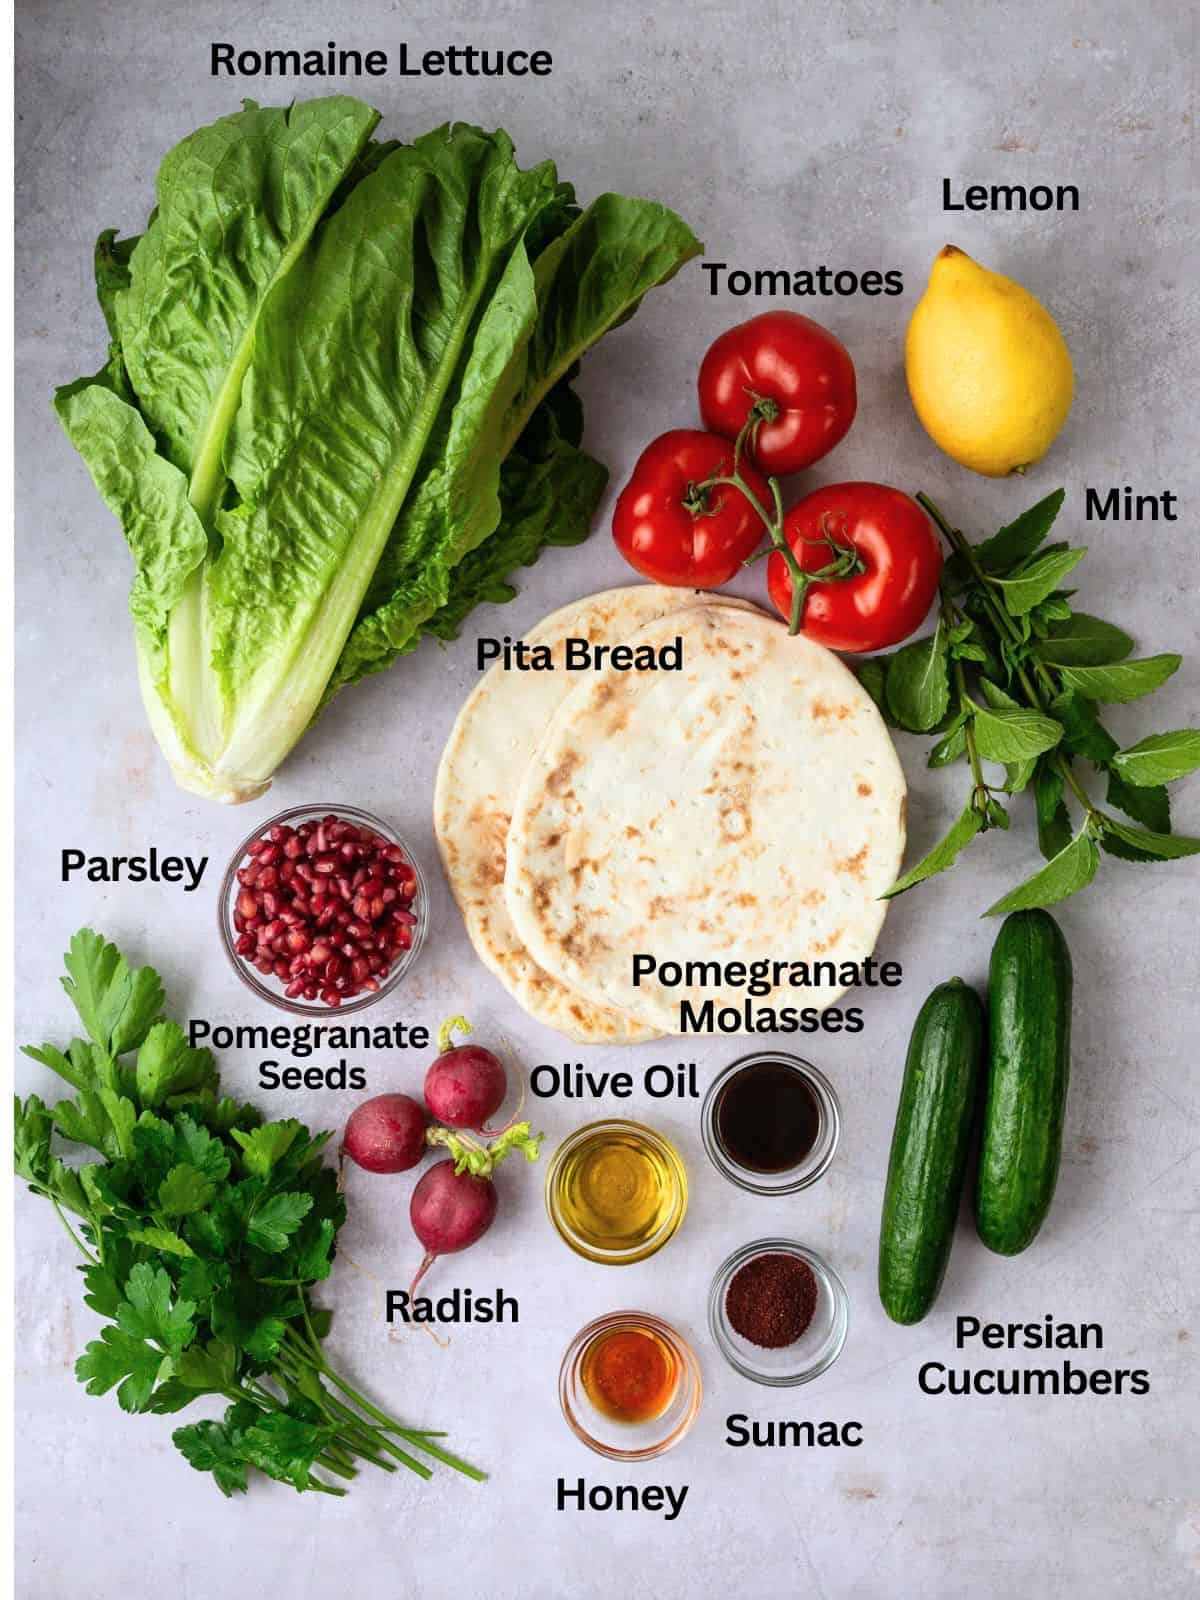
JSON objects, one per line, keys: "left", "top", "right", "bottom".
{"left": 504, "top": 608, "right": 906, "bottom": 1034}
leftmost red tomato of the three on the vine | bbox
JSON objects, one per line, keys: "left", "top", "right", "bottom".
{"left": 613, "top": 427, "right": 771, "bottom": 589}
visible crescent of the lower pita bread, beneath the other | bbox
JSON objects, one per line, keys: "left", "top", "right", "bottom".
{"left": 434, "top": 584, "right": 752, "bottom": 1045}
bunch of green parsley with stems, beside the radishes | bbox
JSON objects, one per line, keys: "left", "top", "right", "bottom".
{"left": 14, "top": 928, "right": 483, "bottom": 1496}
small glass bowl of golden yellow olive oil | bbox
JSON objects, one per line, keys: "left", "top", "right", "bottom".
{"left": 546, "top": 1118, "right": 688, "bottom": 1266}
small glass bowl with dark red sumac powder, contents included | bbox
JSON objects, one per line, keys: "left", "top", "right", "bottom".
{"left": 709, "top": 1238, "right": 850, "bottom": 1389}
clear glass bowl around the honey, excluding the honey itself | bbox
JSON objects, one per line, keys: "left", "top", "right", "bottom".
{"left": 558, "top": 1310, "right": 701, "bottom": 1461}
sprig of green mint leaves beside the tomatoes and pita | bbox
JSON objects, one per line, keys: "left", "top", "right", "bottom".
{"left": 859, "top": 490, "right": 1200, "bottom": 917}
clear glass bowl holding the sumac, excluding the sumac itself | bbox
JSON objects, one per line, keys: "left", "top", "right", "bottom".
{"left": 709, "top": 1238, "right": 850, "bottom": 1389}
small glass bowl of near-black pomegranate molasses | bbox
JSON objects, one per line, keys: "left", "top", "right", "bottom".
{"left": 701, "top": 1051, "right": 842, "bottom": 1195}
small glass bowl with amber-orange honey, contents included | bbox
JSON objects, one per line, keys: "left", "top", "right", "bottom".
{"left": 558, "top": 1310, "right": 701, "bottom": 1461}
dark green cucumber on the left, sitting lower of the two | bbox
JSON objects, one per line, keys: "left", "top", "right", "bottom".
{"left": 878, "top": 978, "right": 987, "bottom": 1323}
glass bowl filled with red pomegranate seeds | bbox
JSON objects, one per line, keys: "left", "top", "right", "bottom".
{"left": 219, "top": 805, "right": 429, "bottom": 1016}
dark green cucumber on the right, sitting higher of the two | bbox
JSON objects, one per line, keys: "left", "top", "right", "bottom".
{"left": 974, "top": 910, "right": 1072, "bottom": 1256}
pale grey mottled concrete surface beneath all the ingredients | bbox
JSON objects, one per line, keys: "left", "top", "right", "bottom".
{"left": 16, "top": 0, "right": 1200, "bottom": 1600}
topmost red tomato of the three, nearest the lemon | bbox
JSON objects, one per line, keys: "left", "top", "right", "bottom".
{"left": 699, "top": 310, "right": 858, "bottom": 477}
